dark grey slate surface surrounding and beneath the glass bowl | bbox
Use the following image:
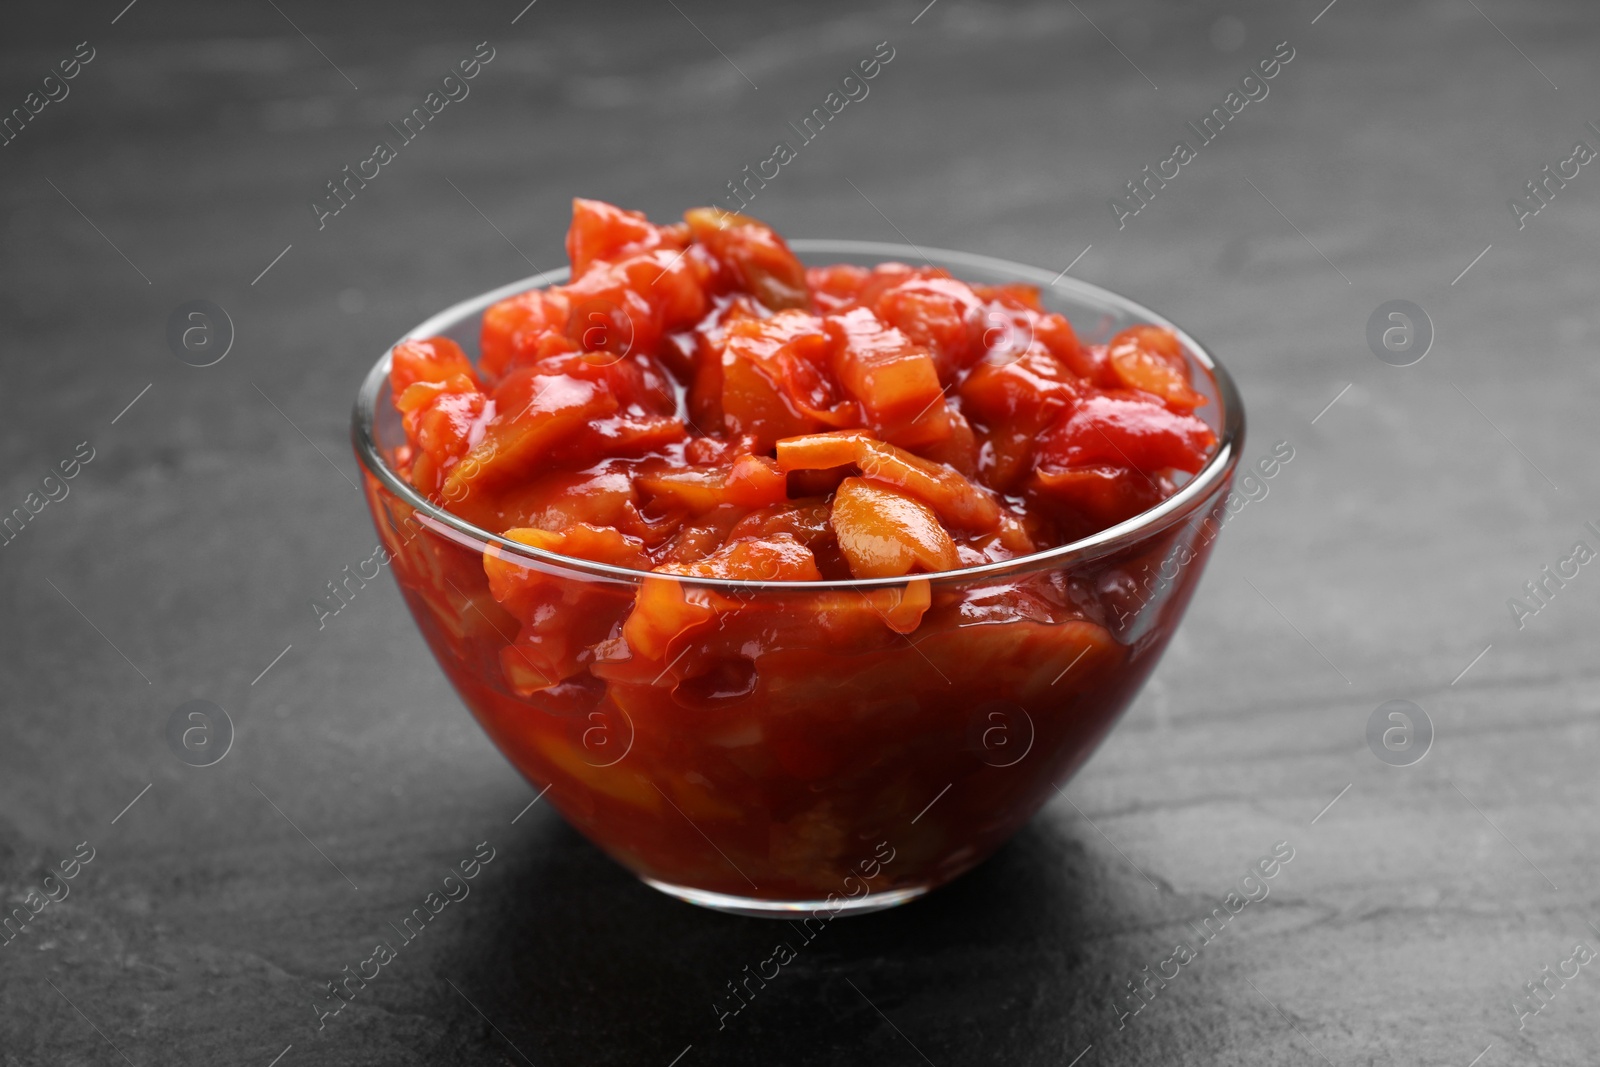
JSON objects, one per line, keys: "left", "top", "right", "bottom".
{"left": 0, "top": 0, "right": 1600, "bottom": 1067}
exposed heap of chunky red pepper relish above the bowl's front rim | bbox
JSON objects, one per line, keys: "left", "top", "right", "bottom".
{"left": 390, "top": 200, "right": 1216, "bottom": 581}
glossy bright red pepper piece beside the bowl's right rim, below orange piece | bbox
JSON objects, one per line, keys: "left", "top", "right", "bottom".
{"left": 1037, "top": 394, "right": 1216, "bottom": 474}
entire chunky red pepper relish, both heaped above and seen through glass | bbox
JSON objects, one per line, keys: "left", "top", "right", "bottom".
{"left": 374, "top": 200, "right": 1216, "bottom": 899}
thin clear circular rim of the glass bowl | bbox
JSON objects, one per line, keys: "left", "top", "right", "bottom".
{"left": 350, "top": 238, "right": 1245, "bottom": 592}
